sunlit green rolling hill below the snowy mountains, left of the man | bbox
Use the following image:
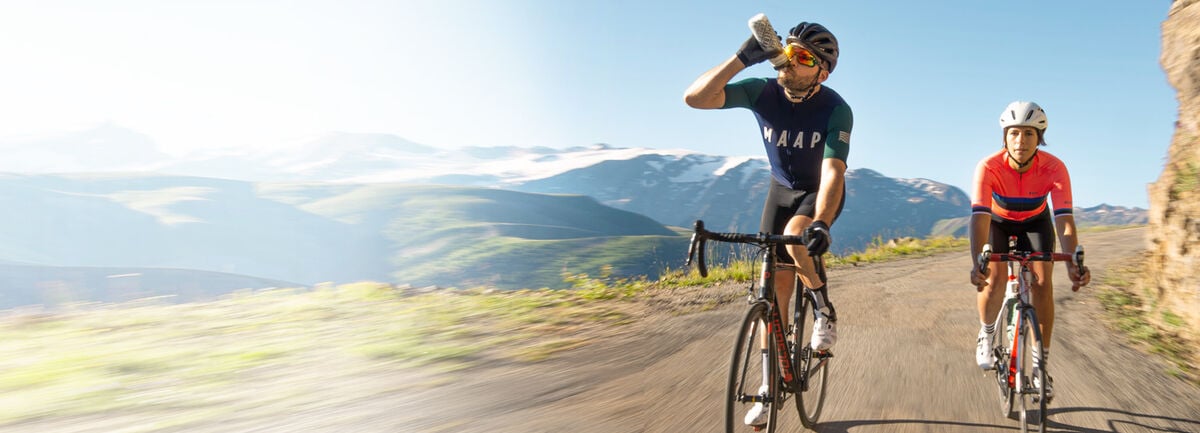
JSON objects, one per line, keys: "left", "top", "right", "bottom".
{"left": 264, "top": 185, "right": 686, "bottom": 289}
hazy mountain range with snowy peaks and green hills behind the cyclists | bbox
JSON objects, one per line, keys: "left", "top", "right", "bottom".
{"left": 0, "top": 125, "right": 1146, "bottom": 306}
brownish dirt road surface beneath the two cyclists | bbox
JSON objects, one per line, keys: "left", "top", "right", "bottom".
{"left": 405, "top": 225, "right": 1200, "bottom": 433}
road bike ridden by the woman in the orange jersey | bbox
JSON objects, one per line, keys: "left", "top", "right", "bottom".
{"left": 976, "top": 236, "right": 1084, "bottom": 433}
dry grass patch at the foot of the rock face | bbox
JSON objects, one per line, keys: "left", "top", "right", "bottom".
{"left": 1097, "top": 254, "right": 1200, "bottom": 385}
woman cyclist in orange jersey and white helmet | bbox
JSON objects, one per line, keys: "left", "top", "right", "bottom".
{"left": 968, "top": 101, "right": 1092, "bottom": 399}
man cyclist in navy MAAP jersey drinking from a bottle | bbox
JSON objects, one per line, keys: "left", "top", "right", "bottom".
{"left": 684, "top": 23, "right": 853, "bottom": 426}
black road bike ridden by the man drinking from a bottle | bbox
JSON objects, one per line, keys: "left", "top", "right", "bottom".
{"left": 686, "top": 221, "right": 833, "bottom": 433}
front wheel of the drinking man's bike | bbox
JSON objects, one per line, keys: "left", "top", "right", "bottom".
{"left": 725, "top": 302, "right": 780, "bottom": 433}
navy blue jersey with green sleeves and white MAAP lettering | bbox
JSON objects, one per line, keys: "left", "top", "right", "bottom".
{"left": 721, "top": 78, "right": 854, "bottom": 191}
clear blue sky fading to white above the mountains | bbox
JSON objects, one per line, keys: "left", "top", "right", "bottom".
{"left": 0, "top": 0, "right": 1177, "bottom": 208}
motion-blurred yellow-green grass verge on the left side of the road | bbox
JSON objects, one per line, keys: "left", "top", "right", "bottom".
{"left": 0, "top": 279, "right": 630, "bottom": 424}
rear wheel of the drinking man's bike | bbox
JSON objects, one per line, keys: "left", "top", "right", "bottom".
{"left": 791, "top": 290, "right": 833, "bottom": 428}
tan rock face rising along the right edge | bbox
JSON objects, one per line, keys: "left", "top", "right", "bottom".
{"left": 1148, "top": 0, "right": 1200, "bottom": 335}
